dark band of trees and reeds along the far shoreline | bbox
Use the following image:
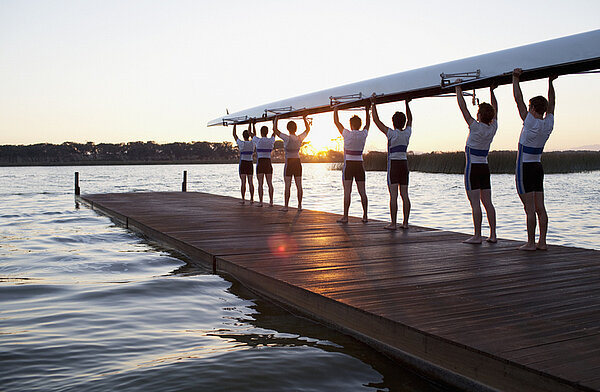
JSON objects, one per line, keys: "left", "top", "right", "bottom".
{"left": 9, "top": 140, "right": 600, "bottom": 173}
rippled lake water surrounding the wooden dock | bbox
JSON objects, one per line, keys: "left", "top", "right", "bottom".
{"left": 0, "top": 164, "right": 600, "bottom": 391}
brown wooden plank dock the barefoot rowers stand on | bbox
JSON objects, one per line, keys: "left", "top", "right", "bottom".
{"left": 77, "top": 192, "right": 600, "bottom": 391}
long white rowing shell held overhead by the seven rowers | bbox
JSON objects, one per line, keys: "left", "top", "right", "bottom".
{"left": 208, "top": 30, "right": 600, "bottom": 126}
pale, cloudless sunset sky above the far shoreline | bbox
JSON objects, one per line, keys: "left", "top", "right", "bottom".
{"left": 0, "top": 0, "right": 600, "bottom": 152}
